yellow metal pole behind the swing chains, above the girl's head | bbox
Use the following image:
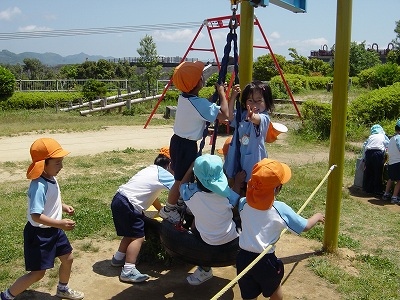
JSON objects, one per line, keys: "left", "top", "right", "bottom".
{"left": 239, "top": 1, "right": 254, "bottom": 90}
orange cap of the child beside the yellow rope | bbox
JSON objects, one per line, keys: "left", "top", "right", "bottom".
{"left": 246, "top": 158, "right": 292, "bottom": 210}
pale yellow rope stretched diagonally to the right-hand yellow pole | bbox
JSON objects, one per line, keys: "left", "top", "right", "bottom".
{"left": 211, "top": 165, "right": 336, "bottom": 300}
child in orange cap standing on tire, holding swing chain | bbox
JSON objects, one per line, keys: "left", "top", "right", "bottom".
{"left": 160, "top": 61, "right": 228, "bottom": 223}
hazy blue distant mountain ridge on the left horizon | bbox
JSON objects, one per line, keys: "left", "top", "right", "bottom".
{"left": 0, "top": 50, "right": 114, "bottom": 66}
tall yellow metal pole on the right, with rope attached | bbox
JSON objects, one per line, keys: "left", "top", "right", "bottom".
{"left": 323, "top": 0, "right": 352, "bottom": 253}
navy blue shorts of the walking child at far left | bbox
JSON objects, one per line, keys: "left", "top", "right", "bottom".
{"left": 24, "top": 222, "right": 72, "bottom": 271}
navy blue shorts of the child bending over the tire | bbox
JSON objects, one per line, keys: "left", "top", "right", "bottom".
{"left": 111, "top": 193, "right": 144, "bottom": 238}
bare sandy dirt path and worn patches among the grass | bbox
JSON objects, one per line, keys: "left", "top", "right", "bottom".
{"left": 0, "top": 126, "right": 400, "bottom": 300}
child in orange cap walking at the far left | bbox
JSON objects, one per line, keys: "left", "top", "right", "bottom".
{"left": 1, "top": 138, "right": 84, "bottom": 300}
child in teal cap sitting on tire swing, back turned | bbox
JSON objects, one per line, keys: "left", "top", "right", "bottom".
{"left": 180, "top": 154, "right": 244, "bottom": 285}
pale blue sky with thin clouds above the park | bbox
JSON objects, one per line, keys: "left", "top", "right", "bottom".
{"left": 0, "top": 0, "right": 400, "bottom": 61}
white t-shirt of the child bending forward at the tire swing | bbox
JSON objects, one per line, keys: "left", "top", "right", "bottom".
{"left": 117, "top": 165, "right": 175, "bottom": 212}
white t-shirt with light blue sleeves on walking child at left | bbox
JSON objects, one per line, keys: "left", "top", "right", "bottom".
{"left": 27, "top": 177, "right": 62, "bottom": 228}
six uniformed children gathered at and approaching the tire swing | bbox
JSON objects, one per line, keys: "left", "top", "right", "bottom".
{"left": 1, "top": 62, "right": 324, "bottom": 300}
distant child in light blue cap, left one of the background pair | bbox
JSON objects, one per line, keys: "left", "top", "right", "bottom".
{"left": 362, "top": 124, "right": 389, "bottom": 197}
